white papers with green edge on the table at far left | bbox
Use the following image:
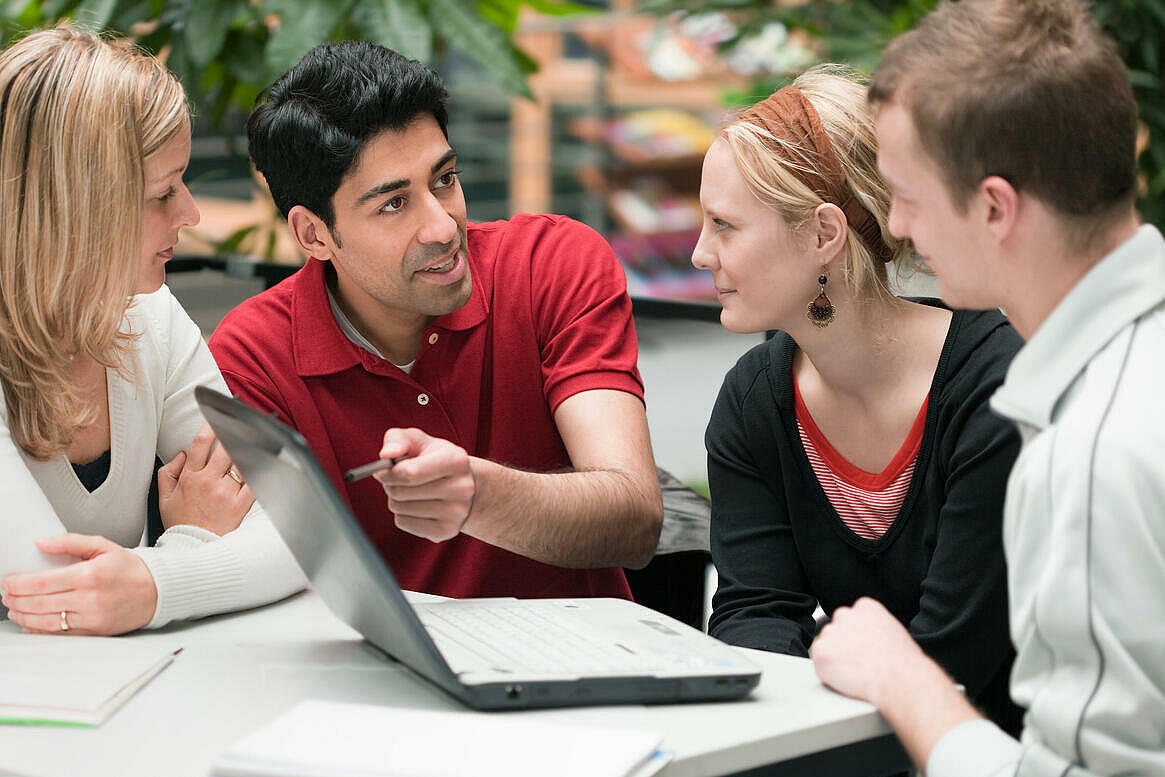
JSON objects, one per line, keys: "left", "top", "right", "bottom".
{"left": 0, "top": 634, "right": 177, "bottom": 726}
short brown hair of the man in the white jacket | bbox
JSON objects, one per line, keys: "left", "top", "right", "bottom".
{"left": 869, "top": 0, "right": 1137, "bottom": 226}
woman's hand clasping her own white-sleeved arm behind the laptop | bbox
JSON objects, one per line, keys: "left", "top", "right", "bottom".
{"left": 157, "top": 424, "right": 255, "bottom": 536}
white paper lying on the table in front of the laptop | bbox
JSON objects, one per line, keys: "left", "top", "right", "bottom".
{"left": 213, "top": 700, "right": 663, "bottom": 777}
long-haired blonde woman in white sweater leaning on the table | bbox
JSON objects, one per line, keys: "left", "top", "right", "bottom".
{"left": 0, "top": 27, "right": 304, "bottom": 634}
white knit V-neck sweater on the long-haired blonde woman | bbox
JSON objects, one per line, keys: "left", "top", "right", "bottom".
{"left": 0, "top": 285, "right": 306, "bottom": 628}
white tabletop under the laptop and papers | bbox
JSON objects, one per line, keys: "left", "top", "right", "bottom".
{"left": 0, "top": 593, "right": 908, "bottom": 777}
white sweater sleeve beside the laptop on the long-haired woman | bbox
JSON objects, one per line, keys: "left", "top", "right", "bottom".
{"left": 135, "top": 287, "right": 306, "bottom": 628}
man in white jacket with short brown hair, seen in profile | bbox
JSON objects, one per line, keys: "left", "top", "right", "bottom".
{"left": 812, "top": 0, "right": 1165, "bottom": 777}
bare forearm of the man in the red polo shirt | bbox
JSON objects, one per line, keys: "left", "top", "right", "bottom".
{"left": 463, "top": 458, "right": 663, "bottom": 568}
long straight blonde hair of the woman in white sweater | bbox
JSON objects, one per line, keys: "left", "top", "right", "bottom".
{"left": 0, "top": 24, "right": 190, "bottom": 459}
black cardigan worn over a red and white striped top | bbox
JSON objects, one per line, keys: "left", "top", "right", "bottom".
{"left": 705, "top": 299, "right": 1023, "bottom": 733}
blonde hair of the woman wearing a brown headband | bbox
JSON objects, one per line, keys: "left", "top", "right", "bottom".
{"left": 721, "top": 64, "right": 911, "bottom": 302}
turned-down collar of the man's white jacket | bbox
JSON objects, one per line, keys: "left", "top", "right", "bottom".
{"left": 991, "top": 225, "right": 1165, "bottom": 429}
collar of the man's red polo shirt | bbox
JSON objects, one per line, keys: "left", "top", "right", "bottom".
{"left": 291, "top": 250, "right": 489, "bottom": 376}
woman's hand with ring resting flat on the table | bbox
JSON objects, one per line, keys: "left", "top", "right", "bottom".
{"left": 0, "top": 534, "right": 157, "bottom": 635}
